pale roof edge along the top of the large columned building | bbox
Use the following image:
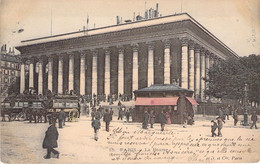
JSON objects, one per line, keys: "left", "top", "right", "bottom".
{"left": 16, "top": 13, "right": 238, "bottom": 57}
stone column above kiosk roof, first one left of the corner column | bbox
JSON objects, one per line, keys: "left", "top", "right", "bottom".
{"left": 164, "top": 40, "right": 171, "bottom": 84}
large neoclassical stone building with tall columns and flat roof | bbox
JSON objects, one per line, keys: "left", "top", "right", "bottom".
{"left": 16, "top": 13, "right": 238, "bottom": 101}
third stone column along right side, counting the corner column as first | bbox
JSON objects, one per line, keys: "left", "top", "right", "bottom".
{"left": 194, "top": 47, "right": 201, "bottom": 99}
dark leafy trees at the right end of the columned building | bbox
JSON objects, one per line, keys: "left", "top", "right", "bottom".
{"left": 205, "top": 55, "right": 260, "bottom": 103}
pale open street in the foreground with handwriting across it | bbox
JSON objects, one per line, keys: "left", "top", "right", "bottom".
{"left": 0, "top": 115, "right": 260, "bottom": 163}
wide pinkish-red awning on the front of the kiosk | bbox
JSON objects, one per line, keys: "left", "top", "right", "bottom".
{"left": 135, "top": 97, "right": 179, "bottom": 106}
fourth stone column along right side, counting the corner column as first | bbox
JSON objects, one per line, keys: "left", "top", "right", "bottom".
{"left": 200, "top": 50, "right": 206, "bottom": 101}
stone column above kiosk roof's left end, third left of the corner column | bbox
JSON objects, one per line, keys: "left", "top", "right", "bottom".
{"left": 132, "top": 44, "right": 138, "bottom": 98}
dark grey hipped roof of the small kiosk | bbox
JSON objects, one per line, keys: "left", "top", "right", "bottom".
{"left": 134, "top": 84, "right": 193, "bottom": 93}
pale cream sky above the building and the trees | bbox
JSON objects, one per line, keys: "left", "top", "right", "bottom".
{"left": 0, "top": 0, "right": 260, "bottom": 56}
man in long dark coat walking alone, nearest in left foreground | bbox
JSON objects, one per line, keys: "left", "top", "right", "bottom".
{"left": 42, "top": 122, "right": 60, "bottom": 159}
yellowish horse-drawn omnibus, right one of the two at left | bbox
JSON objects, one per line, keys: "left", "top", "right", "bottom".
{"left": 48, "top": 95, "right": 80, "bottom": 121}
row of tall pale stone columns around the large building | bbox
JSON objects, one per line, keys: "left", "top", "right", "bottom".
{"left": 20, "top": 38, "right": 218, "bottom": 100}
